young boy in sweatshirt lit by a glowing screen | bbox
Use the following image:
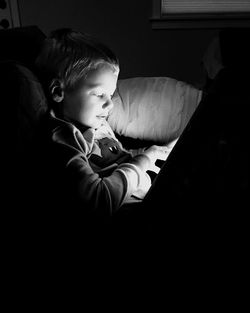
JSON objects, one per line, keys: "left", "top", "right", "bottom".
{"left": 37, "top": 29, "right": 173, "bottom": 222}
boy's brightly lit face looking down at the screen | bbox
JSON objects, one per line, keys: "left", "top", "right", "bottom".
{"left": 62, "top": 66, "right": 118, "bottom": 128}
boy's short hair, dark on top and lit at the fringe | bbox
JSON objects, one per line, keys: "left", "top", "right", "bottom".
{"left": 36, "top": 28, "right": 119, "bottom": 94}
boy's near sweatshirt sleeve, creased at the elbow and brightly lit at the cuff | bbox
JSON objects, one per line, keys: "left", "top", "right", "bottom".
{"left": 66, "top": 148, "right": 151, "bottom": 215}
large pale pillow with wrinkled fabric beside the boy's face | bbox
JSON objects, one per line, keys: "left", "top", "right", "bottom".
{"left": 108, "top": 77, "right": 202, "bottom": 143}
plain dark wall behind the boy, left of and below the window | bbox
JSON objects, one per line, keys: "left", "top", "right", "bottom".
{"left": 19, "top": 0, "right": 217, "bottom": 87}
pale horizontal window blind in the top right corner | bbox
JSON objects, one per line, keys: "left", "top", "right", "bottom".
{"left": 161, "top": 0, "right": 250, "bottom": 15}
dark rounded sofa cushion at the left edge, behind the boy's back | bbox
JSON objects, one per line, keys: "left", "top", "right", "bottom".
{"left": 0, "top": 61, "right": 47, "bottom": 153}
